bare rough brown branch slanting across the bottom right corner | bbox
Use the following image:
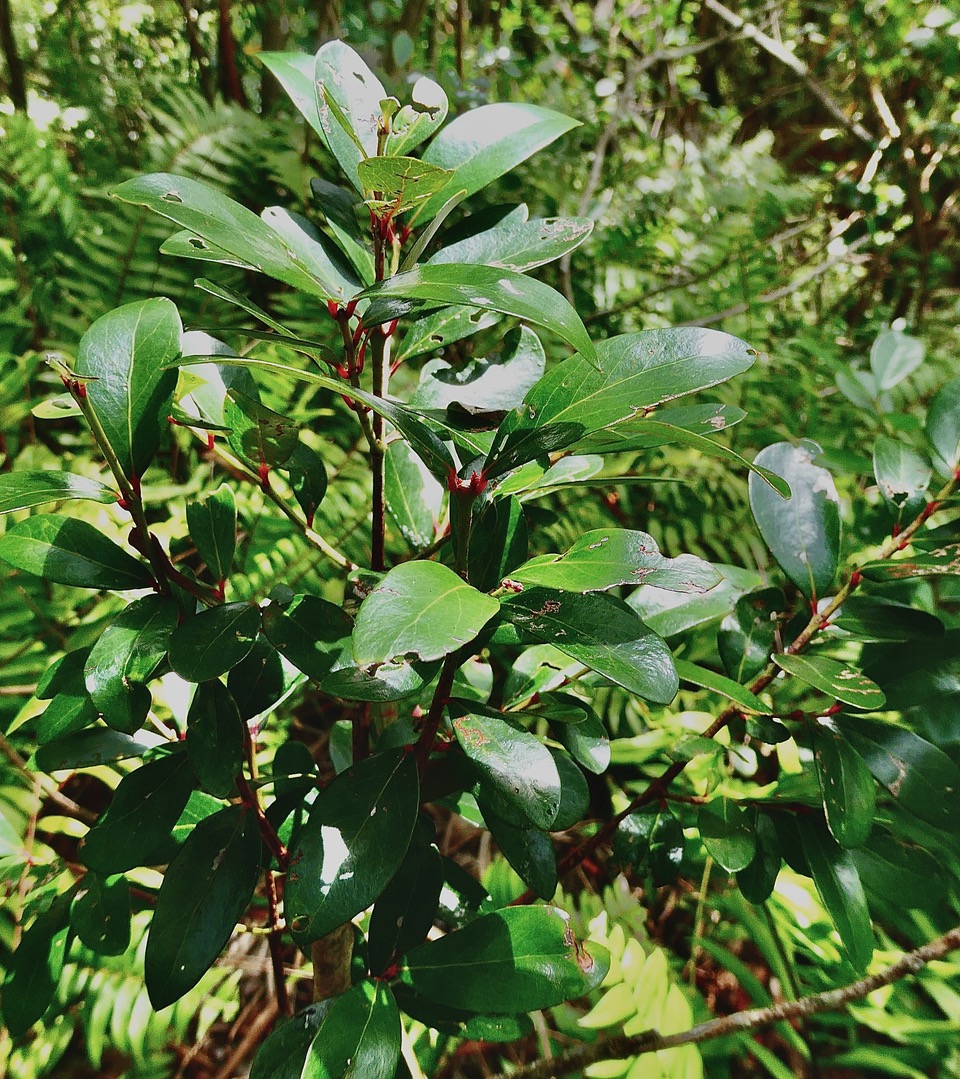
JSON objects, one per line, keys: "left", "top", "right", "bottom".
{"left": 493, "top": 926, "right": 960, "bottom": 1079}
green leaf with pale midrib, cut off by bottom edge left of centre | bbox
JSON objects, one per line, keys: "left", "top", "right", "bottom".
{"left": 301, "top": 981, "right": 400, "bottom": 1079}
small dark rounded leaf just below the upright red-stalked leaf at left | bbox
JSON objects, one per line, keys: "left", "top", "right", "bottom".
{"left": 169, "top": 603, "right": 260, "bottom": 682}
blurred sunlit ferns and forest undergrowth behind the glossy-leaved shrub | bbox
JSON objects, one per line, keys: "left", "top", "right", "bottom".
{"left": 0, "top": 0, "right": 960, "bottom": 1079}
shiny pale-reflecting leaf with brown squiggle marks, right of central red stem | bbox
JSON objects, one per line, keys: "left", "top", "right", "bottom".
{"left": 453, "top": 713, "right": 560, "bottom": 829}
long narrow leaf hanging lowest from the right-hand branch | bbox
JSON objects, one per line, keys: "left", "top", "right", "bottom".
{"left": 796, "top": 816, "right": 874, "bottom": 971}
